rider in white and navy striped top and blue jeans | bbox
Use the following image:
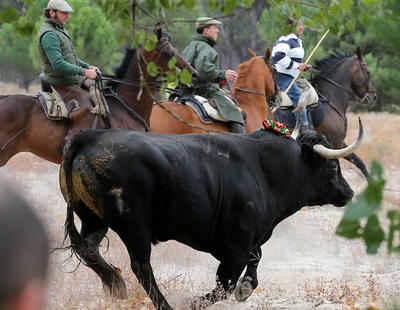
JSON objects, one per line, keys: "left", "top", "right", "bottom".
{"left": 271, "top": 19, "right": 311, "bottom": 127}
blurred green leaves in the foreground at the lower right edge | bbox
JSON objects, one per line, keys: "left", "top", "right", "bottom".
{"left": 336, "top": 161, "right": 400, "bottom": 254}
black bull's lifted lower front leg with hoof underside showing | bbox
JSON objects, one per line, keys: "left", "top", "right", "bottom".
{"left": 235, "top": 247, "right": 262, "bottom": 301}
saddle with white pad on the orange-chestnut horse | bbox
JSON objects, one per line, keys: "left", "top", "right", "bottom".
{"left": 174, "top": 95, "right": 229, "bottom": 124}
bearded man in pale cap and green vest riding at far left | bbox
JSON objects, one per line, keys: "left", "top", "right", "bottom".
{"left": 38, "top": 0, "right": 105, "bottom": 140}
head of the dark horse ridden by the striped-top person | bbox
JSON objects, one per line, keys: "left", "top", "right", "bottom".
{"left": 351, "top": 47, "right": 377, "bottom": 104}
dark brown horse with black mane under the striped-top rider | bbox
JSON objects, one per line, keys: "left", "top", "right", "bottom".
{"left": 274, "top": 48, "right": 377, "bottom": 178}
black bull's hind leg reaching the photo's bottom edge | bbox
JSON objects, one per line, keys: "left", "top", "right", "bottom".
{"left": 111, "top": 218, "right": 172, "bottom": 310}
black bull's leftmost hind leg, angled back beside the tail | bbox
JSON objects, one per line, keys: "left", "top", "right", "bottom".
{"left": 65, "top": 202, "right": 127, "bottom": 298}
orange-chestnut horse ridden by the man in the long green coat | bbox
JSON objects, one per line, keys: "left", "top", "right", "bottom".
{"left": 150, "top": 48, "right": 275, "bottom": 134}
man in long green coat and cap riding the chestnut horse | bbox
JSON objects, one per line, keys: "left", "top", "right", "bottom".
{"left": 182, "top": 17, "right": 246, "bottom": 133}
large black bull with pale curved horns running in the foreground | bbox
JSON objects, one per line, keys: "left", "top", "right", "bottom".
{"left": 60, "top": 122, "right": 362, "bottom": 309}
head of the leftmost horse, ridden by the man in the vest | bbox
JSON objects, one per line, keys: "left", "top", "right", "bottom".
{"left": 146, "top": 23, "right": 198, "bottom": 79}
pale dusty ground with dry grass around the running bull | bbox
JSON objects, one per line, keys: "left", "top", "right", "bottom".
{"left": 0, "top": 81, "right": 400, "bottom": 310}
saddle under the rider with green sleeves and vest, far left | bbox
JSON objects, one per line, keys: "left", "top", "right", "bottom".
{"left": 37, "top": 73, "right": 80, "bottom": 120}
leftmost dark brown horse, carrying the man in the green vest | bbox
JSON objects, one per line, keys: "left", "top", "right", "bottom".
{"left": 0, "top": 28, "right": 197, "bottom": 167}
